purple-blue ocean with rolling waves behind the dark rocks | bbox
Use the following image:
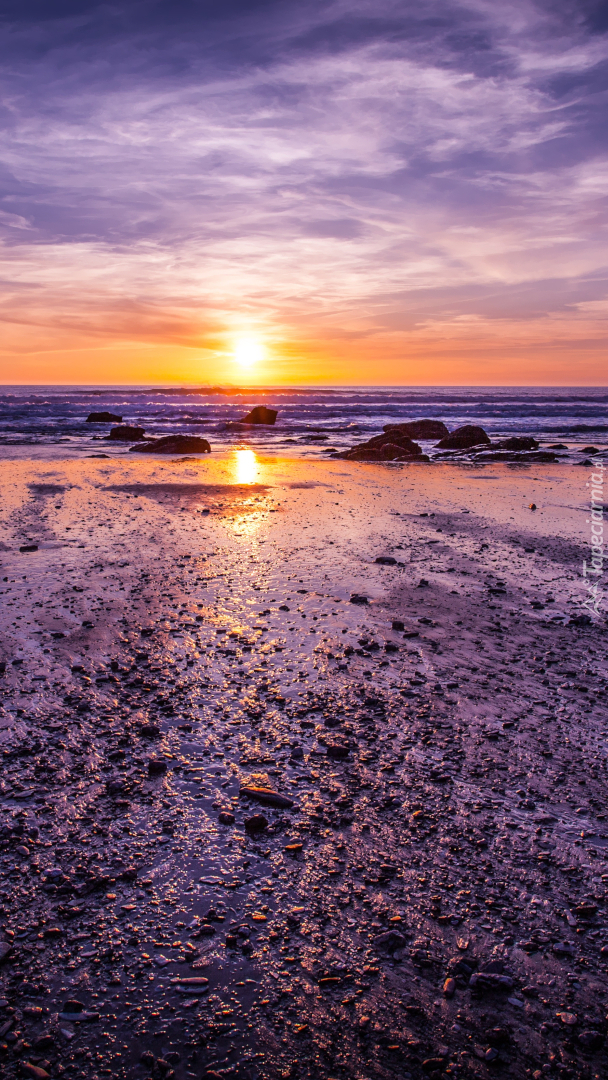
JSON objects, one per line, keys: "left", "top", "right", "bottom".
{"left": 0, "top": 386, "right": 608, "bottom": 460}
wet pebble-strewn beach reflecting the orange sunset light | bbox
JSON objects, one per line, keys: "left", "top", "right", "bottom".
{"left": 0, "top": 450, "right": 608, "bottom": 1080}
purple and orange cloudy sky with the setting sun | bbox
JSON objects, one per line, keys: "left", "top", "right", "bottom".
{"left": 0, "top": 0, "right": 608, "bottom": 386}
